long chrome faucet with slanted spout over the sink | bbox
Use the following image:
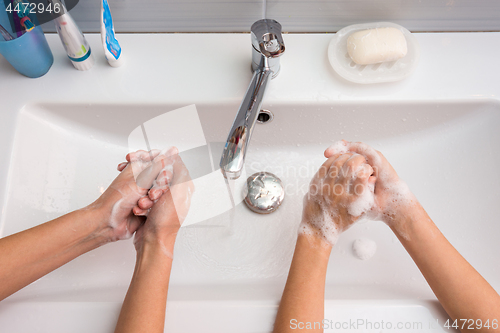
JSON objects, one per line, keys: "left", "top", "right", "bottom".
{"left": 220, "top": 19, "right": 285, "bottom": 179}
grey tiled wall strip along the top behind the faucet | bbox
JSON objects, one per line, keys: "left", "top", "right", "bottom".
{"left": 44, "top": 0, "right": 500, "bottom": 32}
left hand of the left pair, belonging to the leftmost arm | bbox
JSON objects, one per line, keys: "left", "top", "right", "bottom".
{"left": 88, "top": 148, "right": 177, "bottom": 241}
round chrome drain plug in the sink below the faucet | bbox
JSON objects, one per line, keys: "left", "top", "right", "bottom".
{"left": 245, "top": 171, "right": 285, "bottom": 214}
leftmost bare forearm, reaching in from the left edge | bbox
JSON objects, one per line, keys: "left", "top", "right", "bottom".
{"left": 0, "top": 209, "right": 107, "bottom": 300}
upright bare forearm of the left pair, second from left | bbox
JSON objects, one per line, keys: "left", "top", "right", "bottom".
{"left": 115, "top": 236, "right": 173, "bottom": 333}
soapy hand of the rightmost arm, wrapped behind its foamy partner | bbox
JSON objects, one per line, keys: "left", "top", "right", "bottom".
{"left": 325, "top": 141, "right": 423, "bottom": 236}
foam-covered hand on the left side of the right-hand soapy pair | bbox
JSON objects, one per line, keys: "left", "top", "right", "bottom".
{"left": 300, "top": 153, "right": 376, "bottom": 245}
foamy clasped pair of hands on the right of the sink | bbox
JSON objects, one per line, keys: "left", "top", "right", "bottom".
{"left": 302, "top": 141, "right": 421, "bottom": 244}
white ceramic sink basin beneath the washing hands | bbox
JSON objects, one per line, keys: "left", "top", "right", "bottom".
{"left": 0, "top": 100, "right": 500, "bottom": 332}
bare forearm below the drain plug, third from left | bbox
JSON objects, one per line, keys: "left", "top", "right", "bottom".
{"left": 274, "top": 234, "right": 331, "bottom": 333}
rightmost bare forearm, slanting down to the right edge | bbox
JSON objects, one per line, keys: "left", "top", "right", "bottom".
{"left": 399, "top": 209, "right": 500, "bottom": 332}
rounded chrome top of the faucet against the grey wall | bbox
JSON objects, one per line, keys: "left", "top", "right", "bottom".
{"left": 250, "top": 19, "right": 285, "bottom": 58}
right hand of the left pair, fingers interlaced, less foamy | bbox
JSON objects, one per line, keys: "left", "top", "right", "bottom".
{"left": 134, "top": 154, "right": 194, "bottom": 257}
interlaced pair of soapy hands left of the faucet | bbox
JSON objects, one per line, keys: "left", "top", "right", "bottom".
{"left": 91, "top": 148, "right": 194, "bottom": 251}
